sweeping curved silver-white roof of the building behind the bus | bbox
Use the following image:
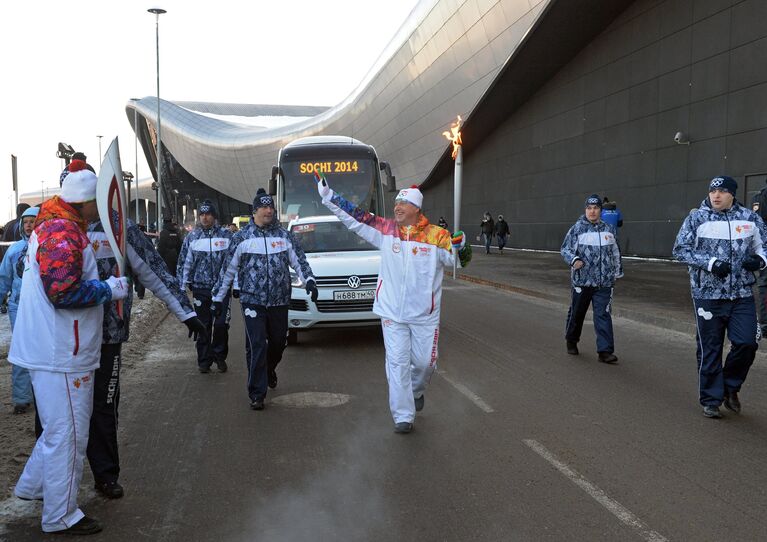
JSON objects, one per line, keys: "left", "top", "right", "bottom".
{"left": 126, "top": 0, "right": 553, "bottom": 202}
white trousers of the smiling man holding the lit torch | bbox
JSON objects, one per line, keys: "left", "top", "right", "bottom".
{"left": 381, "top": 319, "right": 439, "bottom": 423}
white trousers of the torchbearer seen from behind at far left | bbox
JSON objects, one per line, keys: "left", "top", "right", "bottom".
{"left": 14, "top": 370, "right": 93, "bottom": 532}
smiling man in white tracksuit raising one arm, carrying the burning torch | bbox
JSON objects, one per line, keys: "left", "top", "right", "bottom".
{"left": 317, "top": 177, "right": 471, "bottom": 433}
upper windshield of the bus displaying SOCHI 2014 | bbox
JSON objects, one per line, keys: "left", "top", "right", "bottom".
{"left": 280, "top": 156, "right": 381, "bottom": 222}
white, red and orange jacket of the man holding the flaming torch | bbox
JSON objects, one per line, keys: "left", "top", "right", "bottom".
{"left": 323, "top": 191, "right": 470, "bottom": 325}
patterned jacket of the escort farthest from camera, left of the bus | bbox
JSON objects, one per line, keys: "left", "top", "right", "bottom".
{"left": 176, "top": 226, "right": 233, "bottom": 291}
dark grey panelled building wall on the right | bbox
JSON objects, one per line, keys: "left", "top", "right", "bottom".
{"left": 425, "top": 0, "right": 767, "bottom": 257}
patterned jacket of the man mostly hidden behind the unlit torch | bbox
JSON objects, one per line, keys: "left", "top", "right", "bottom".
{"left": 88, "top": 220, "right": 197, "bottom": 344}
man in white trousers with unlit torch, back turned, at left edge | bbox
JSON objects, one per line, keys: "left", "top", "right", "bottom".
{"left": 8, "top": 164, "right": 129, "bottom": 534}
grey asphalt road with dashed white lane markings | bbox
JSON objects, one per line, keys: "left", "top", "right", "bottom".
{"left": 4, "top": 281, "right": 767, "bottom": 542}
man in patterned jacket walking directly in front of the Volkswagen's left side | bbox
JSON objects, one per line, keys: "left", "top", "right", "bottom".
{"left": 212, "top": 188, "right": 318, "bottom": 410}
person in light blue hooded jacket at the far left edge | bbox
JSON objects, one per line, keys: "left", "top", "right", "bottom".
{"left": 0, "top": 207, "right": 40, "bottom": 414}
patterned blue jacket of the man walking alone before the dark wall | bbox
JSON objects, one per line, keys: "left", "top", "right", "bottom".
{"left": 560, "top": 215, "right": 623, "bottom": 288}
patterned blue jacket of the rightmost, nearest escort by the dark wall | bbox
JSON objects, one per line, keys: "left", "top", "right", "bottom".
{"left": 673, "top": 198, "right": 767, "bottom": 299}
